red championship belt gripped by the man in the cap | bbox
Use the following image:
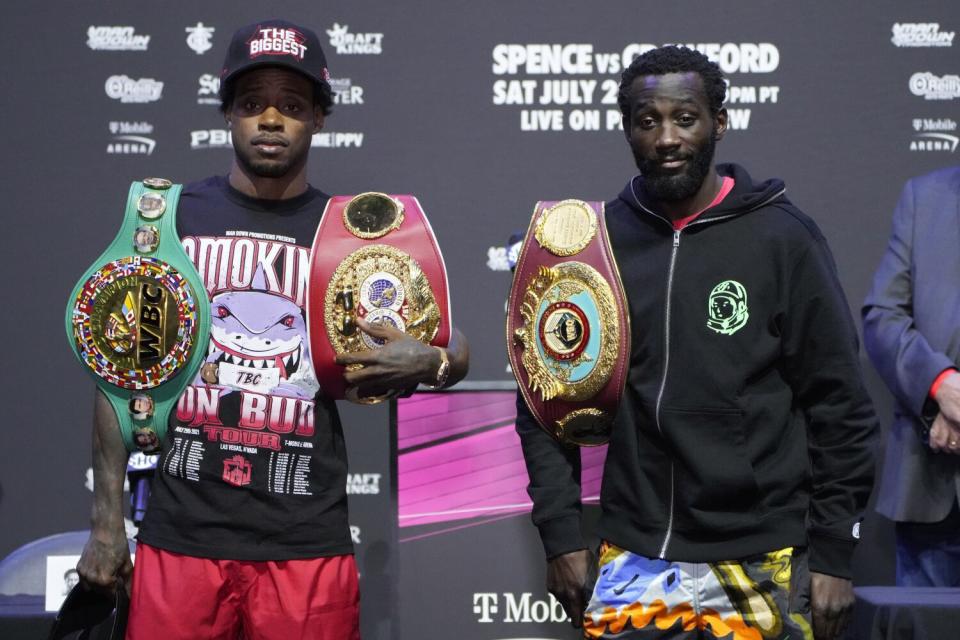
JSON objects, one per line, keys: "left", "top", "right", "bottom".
{"left": 307, "top": 192, "right": 451, "bottom": 403}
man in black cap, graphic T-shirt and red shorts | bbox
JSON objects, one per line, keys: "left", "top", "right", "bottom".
{"left": 78, "top": 20, "right": 467, "bottom": 640}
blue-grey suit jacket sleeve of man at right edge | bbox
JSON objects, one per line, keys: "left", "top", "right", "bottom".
{"left": 862, "top": 180, "right": 956, "bottom": 420}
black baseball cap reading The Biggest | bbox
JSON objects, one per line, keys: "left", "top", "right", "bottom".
{"left": 220, "top": 20, "right": 330, "bottom": 97}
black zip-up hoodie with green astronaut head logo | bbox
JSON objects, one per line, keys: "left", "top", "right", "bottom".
{"left": 517, "top": 165, "right": 877, "bottom": 577}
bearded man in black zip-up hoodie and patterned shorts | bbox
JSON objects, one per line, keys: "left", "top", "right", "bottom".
{"left": 517, "top": 47, "right": 876, "bottom": 640}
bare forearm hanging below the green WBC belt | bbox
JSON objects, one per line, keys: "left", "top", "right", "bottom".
{"left": 90, "top": 391, "right": 128, "bottom": 536}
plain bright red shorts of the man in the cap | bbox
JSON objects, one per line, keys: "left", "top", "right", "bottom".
{"left": 126, "top": 544, "right": 360, "bottom": 640}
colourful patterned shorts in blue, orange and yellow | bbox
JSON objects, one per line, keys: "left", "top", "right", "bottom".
{"left": 583, "top": 543, "right": 813, "bottom": 640}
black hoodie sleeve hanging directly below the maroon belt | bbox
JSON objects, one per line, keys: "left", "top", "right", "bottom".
{"left": 517, "top": 392, "right": 586, "bottom": 559}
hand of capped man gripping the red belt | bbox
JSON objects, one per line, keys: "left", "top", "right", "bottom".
{"left": 337, "top": 318, "right": 440, "bottom": 397}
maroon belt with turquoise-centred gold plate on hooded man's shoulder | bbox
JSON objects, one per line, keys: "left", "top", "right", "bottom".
{"left": 507, "top": 200, "right": 630, "bottom": 446}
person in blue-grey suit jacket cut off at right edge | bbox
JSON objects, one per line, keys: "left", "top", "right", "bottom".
{"left": 863, "top": 167, "right": 960, "bottom": 587}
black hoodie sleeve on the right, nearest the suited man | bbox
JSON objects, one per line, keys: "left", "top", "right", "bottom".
{"left": 783, "top": 233, "right": 878, "bottom": 578}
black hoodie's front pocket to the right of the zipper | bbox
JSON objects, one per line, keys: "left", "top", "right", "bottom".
{"left": 661, "top": 408, "right": 760, "bottom": 529}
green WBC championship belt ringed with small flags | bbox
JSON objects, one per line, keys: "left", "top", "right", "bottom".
{"left": 66, "top": 178, "right": 210, "bottom": 453}
